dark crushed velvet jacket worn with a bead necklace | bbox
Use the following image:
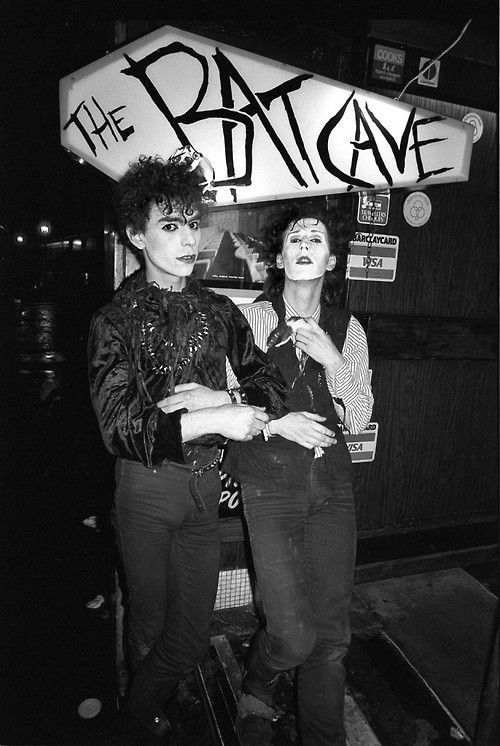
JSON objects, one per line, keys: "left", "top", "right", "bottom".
{"left": 88, "top": 270, "right": 287, "bottom": 467}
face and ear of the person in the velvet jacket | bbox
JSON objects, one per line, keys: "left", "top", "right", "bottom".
{"left": 127, "top": 204, "right": 200, "bottom": 290}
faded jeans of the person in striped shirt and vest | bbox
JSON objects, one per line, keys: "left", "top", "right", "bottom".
{"left": 239, "top": 443, "right": 356, "bottom": 746}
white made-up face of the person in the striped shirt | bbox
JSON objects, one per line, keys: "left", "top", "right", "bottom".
{"left": 276, "top": 218, "right": 335, "bottom": 280}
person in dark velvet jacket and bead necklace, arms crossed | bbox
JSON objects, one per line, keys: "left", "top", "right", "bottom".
{"left": 88, "top": 149, "right": 287, "bottom": 743}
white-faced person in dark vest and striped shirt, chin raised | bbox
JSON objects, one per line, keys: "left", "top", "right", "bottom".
{"left": 229, "top": 202, "right": 373, "bottom": 746}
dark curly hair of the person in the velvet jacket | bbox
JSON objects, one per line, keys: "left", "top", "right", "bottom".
{"left": 114, "top": 155, "right": 203, "bottom": 258}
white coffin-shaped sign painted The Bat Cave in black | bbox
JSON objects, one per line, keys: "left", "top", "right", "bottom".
{"left": 60, "top": 26, "right": 473, "bottom": 204}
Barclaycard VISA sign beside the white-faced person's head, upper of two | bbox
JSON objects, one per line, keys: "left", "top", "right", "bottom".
{"left": 346, "top": 231, "right": 399, "bottom": 282}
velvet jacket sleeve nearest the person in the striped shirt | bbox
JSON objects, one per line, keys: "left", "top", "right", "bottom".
{"left": 227, "top": 299, "right": 289, "bottom": 418}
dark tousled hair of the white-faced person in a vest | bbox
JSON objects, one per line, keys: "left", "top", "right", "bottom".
{"left": 261, "top": 198, "right": 354, "bottom": 305}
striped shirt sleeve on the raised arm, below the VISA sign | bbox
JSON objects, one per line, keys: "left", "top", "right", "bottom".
{"left": 326, "top": 316, "right": 373, "bottom": 434}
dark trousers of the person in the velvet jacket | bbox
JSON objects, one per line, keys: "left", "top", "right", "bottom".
{"left": 115, "top": 460, "right": 221, "bottom": 721}
